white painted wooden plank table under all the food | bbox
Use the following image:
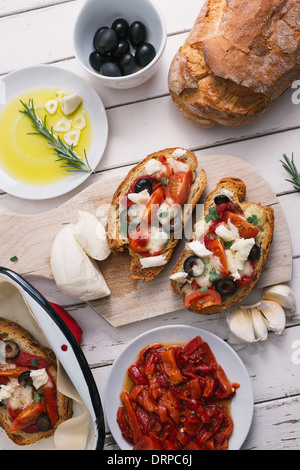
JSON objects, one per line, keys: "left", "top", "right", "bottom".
{"left": 0, "top": 0, "right": 300, "bottom": 450}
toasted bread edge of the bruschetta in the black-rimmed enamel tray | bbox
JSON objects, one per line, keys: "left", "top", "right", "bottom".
{"left": 0, "top": 318, "right": 73, "bottom": 446}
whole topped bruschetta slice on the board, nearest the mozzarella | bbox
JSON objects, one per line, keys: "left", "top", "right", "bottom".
{"left": 106, "top": 148, "right": 206, "bottom": 281}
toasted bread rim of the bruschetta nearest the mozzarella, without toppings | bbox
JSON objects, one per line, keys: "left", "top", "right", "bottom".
{"left": 106, "top": 148, "right": 206, "bottom": 281}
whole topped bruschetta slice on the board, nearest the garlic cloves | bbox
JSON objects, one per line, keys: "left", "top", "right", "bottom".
{"left": 170, "top": 177, "right": 274, "bottom": 315}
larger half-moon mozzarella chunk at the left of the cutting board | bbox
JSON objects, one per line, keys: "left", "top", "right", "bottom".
{"left": 50, "top": 224, "right": 110, "bottom": 302}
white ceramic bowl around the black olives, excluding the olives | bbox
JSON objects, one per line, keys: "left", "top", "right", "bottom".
{"left": 73, "top": 0, "right": 167, "bottom": 89}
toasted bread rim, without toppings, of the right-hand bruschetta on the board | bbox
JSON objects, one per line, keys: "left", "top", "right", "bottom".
{"left": 170, "top": 177, "right": 274, "bottom": 315}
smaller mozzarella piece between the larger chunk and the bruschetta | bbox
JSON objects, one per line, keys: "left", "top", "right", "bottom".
{"left": 71, "top": 211, "right": 111, "bottom": 261}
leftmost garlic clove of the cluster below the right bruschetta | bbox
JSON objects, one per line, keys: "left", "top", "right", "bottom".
{"left": 229, "top": 307, "right": 257, "bottom": 343}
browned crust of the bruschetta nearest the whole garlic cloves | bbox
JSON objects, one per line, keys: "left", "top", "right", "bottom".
{"left": 170, "top": 177, "right": 275, "bottom": 315}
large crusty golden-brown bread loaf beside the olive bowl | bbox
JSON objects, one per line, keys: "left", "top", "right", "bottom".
{"left": 169, "top": 0, "right": 300, "bottom": 127}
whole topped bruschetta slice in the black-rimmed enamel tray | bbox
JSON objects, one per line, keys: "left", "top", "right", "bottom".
{"left": 0, "top": 318, "right": 73, "bottom": 446}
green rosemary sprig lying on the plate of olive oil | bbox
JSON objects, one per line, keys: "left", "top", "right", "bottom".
{"left": 20, "top": 99, "right": 92, "bottom": 173}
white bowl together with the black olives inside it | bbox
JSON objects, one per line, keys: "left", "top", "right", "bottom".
{"left": 74, "top": 0, "right": 167, "bottom": 89}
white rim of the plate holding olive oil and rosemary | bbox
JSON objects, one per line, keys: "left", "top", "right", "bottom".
{"left": 0, "top": 65, "right": 108, "bottom": 200}
